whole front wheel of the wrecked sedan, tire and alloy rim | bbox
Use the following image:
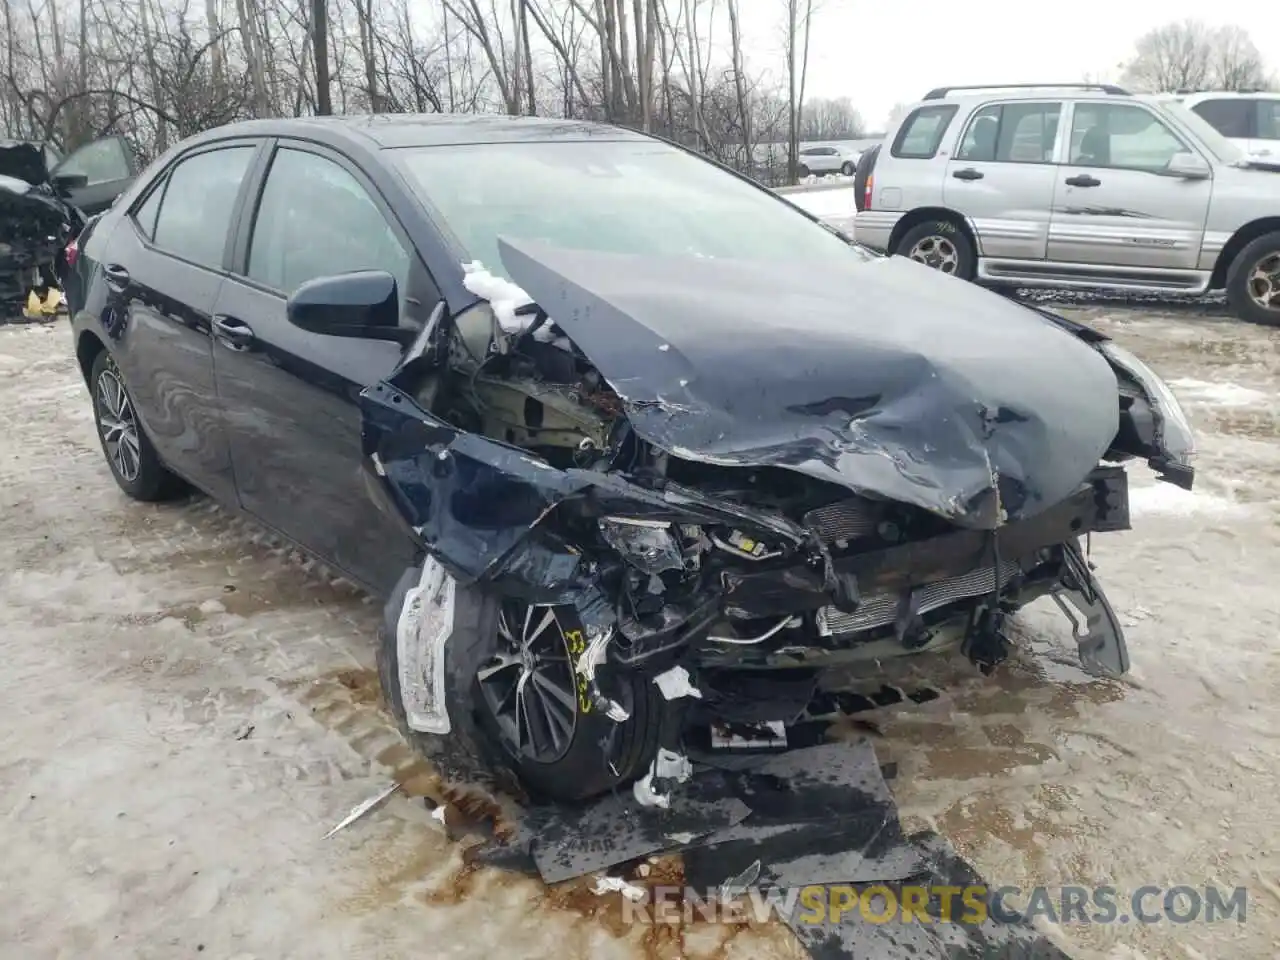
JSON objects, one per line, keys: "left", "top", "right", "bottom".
{"left": 378, "top": 570, "right": 676, "bottom": 801}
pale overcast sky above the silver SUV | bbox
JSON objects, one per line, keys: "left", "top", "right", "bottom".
{"left": 752, "top": 0, "right": 1280, "bottom": 129}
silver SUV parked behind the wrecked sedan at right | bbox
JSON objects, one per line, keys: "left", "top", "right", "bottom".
{"left": 854, "top": 84, "right": 1280, "bottom": 324}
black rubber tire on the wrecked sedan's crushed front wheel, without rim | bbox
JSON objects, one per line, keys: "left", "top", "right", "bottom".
{"left": 378, "top": 570, "right": 673, "bottom": 801}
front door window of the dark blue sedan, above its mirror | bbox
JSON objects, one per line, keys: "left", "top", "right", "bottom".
{"left": 248, "top": 147, "right": 410, "bottom": 297}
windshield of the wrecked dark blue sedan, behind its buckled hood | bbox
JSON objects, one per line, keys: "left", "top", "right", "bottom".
{"left": 394, "top": 141, "right": 872, "bottom": 273}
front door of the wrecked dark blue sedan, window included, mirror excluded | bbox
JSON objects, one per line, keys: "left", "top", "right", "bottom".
{"left": 214, "top": 141, "right": 439, "bottom": 591}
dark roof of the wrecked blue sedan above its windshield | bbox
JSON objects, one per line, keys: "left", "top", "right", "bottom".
{"left": 177, "top": 114, "right": 650, "bottom": 148}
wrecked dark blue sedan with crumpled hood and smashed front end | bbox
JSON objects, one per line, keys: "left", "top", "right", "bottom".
{"left": 68, "top": 115, "right": 1193, "bottom": 804}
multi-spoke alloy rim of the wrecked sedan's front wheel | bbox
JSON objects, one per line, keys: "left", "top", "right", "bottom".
{"left": 476, "top": 600, "right": 579, "bottom": 763}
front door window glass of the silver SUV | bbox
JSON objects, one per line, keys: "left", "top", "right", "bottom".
{"left": 1070, "top": 102, "right": 1189, "bottom": 172}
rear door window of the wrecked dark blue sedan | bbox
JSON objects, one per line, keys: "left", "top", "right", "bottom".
{"left": 152, "top": 146, "right": 257, "bottom": 270}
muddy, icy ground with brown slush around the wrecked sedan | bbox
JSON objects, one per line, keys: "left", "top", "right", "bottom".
{"left": 0, "top": 303, "right": 1280, "bottom": 960}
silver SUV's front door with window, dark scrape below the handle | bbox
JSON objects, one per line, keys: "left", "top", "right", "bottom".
{"left": 1048, "top": 101, "right": 1213, "bottom": 270}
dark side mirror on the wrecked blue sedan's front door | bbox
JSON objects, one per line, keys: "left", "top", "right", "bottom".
{"left": 284, "top": 270, "right": 417, "bottom": 344}
